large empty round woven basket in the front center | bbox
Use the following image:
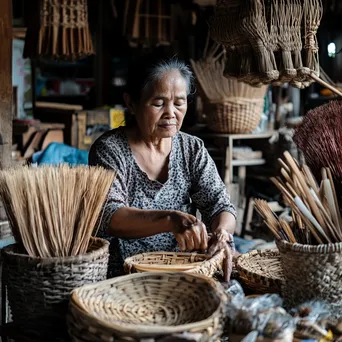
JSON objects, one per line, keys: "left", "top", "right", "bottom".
{"left": 68, "top": 272, "right": 228, "bottom": 342}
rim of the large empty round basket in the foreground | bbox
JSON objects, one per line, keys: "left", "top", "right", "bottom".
{"left": 71, "top": 272, "right": 228, "bottom": 336}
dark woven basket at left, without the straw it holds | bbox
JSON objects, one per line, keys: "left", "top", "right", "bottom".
{"left": 2, "top": 238, "right": 109, "bottom": 341}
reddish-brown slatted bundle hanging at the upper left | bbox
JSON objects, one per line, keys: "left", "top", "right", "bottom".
{"left": 24, "top": 0, "right": 94, "bottom": 60}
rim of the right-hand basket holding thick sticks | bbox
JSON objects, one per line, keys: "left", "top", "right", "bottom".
{"left": 276, "top": 240, "right": 342, "bottom": 254}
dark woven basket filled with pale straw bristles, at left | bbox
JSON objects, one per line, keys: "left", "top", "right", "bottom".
{"left": 0, "top": 166, "right": 115, "bottom": 341}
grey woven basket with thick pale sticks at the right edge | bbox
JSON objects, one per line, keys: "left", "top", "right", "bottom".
{"left": 255, "top": 151, "right": 342, "bottom": 316}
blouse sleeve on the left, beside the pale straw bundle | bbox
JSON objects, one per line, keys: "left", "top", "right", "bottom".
{"left": 88, "top": 143, "right": 128, "bottom": 237}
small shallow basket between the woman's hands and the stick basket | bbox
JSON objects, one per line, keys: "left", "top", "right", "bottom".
{"left": 236, "top": 249, "right": 284, "bottom": 293}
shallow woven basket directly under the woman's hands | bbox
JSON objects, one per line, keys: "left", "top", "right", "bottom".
{"left": 124, "top": 250, "right": 224, "bottom": 277}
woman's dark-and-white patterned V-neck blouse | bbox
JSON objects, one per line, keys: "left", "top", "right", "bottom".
{"left": 89, "top": 127, "right": 236, "bottom": 276}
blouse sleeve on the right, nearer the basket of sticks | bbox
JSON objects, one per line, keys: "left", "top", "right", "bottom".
{"left": 191, "top": 141, "right": 236, "bottom": 227}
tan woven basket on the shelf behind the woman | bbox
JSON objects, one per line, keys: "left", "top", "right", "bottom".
{"left": 203, "top": 98, "right": 264, "bottom": 134}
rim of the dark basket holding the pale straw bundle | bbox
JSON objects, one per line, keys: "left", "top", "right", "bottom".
{"left": 2, "top": 237, "right": 109, "bottom": 265}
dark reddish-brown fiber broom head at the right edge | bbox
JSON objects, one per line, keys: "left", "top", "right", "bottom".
{"left": 294, "top": 101, "right": 342, "bottom": 214}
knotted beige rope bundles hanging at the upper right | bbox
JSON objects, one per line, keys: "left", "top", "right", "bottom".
{"left": 210, "top": 0, "right": 332, "bottom": 88}
